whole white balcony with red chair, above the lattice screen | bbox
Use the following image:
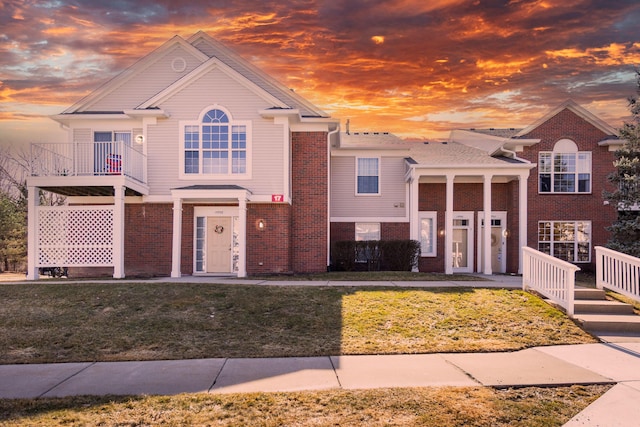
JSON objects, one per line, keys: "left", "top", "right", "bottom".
{"left": 29, "top": 142, "right": 147, "bottom": 196}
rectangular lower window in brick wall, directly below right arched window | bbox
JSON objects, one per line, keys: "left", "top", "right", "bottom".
{"left": 538, "top": 221, "right": 591, "bottom": 262}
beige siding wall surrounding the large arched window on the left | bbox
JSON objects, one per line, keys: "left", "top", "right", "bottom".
{"left": 147, "top": 69, "right": 288, "bottom": 195}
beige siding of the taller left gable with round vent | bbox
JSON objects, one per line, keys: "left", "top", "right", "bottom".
{"left": 83, "top": 46, "right": 202, "bottom": 111}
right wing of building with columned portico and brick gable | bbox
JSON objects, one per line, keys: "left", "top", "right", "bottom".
{"left": 330, "top": 101, "right": 622, "bottom": 273}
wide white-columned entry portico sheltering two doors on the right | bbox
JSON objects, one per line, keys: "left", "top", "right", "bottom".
{"left": 405, "top": 156, "right": 535, "bottom": 274}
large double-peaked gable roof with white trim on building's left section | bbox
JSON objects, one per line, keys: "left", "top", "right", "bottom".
{"left": 57, "top": 31, "right": 329, "bottom": 117}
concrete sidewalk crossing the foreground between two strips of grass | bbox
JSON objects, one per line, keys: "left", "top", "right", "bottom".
{"left": 0, "top": 343, "right": 640, "bottom": 426}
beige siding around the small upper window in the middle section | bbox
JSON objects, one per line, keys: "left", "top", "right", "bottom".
{"left": 331, "top": 157, "right": 408, "bottom": 219}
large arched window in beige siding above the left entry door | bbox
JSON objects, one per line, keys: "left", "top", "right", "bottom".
{"left": 182, "top": 108, "right": 250, "bottom": 181}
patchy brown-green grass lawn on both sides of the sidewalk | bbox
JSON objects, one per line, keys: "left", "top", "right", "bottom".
{"left": 0, "top": 279, "right": 608, "bottom": 426}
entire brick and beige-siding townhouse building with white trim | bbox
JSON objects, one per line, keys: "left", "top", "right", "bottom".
{"left": 28, "top": 32, "right": 620, "bottom": 278}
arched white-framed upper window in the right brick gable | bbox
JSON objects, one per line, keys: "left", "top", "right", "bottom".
{"left": 538, "top": 139, "right": 591, "bottom": 193}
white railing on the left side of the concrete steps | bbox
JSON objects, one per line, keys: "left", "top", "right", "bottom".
{"left": 522, "top": 247, "right": 580, "bottom": 317}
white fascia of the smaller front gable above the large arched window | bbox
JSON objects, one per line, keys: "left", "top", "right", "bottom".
{"left": 137, "top": 56, "right": 289, "bottom": 109}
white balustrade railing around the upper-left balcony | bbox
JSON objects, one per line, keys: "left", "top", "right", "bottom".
{"left": 31, "top": 142, "right": 146, "bottom": 183}
